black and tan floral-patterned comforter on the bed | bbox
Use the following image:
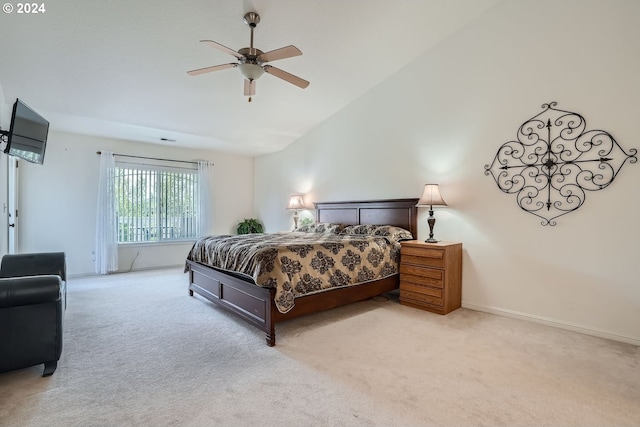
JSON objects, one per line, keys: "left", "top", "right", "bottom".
{"left": 187, "top": 232, "right": 400, "bottom": 313}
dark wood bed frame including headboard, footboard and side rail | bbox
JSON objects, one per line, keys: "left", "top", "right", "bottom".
{"left": 187, "top": 199, "right": 418, "bottom": 346}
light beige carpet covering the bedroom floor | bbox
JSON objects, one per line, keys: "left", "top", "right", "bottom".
{"left": 0, "top": 268, "right": 640, "bottom": 427}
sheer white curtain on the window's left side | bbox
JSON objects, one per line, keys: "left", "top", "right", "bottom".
{"left": 96, "top": 151, "right": 118, "bottom": 274}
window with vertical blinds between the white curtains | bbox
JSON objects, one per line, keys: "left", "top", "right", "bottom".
{"left": 114, "top": 163, "right": 199, "bottom": 243}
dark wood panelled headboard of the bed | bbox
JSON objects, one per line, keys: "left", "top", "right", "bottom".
{"left": 314, "top": 199, "right": 419, "bottom": 239}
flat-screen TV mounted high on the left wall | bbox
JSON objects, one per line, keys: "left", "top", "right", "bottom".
{"left": 4, "top": 99, "right": 49, "bottom": 164}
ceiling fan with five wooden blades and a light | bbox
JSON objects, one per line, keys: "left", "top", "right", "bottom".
{"left": 187, "top": 12, "right": 309, "bottom": 102}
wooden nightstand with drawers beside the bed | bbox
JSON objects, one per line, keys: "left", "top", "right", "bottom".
{"left": 400, "top": 240, "right": 462, "bottom": 314}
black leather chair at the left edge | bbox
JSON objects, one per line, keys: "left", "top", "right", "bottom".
{"left": 0, "top": 252, "right": 67, "bottom": 377}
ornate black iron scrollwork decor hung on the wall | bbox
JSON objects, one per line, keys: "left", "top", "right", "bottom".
{"left": 484, "top": 102, "right": 638, "bottom": 226}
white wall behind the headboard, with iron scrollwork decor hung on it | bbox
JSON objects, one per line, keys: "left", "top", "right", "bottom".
{"left": 254, "top": 0, "right": 640, "bottom": 344}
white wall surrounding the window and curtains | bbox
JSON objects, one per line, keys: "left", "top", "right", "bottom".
{"left": 19, "top": 131, "right": 253, "bottom": 275}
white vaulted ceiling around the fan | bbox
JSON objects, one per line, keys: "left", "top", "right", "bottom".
{"left": 0, "top": 0, "right": 501, "bottom": 156}
